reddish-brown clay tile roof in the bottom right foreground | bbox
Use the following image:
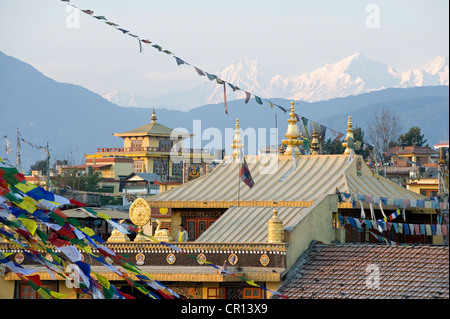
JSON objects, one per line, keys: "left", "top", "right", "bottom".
{"left": 274, "top": 243, "right": 449, "bottom": 299}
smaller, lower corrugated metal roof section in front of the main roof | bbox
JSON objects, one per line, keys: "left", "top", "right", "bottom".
{"left": 196, "top": 207, "right": 311, "bottom": 243}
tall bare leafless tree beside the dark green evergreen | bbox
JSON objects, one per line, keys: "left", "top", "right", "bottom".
{"left": 367, "top": 109, "right": 403, "bottom": 162}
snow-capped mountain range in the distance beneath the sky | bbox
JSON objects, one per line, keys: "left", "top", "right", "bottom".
{"left": 103, "top": 53, "right": 449, "bottom": 111}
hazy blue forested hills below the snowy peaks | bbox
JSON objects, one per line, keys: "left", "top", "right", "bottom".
{"left": 0, "top": 51, "right": 449, "bottom": 170}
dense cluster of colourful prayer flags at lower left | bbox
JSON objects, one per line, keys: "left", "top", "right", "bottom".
{"left": 0, "top": 167, "right": 180, "bottom": 299}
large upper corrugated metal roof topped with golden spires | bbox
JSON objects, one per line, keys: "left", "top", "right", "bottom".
{"left": 147, "top": 155, "right": 425, "bottom": 205}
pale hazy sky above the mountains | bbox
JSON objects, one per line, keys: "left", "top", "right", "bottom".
{"left": 0, "top": 0, "right": 449, "bottom": 97}
